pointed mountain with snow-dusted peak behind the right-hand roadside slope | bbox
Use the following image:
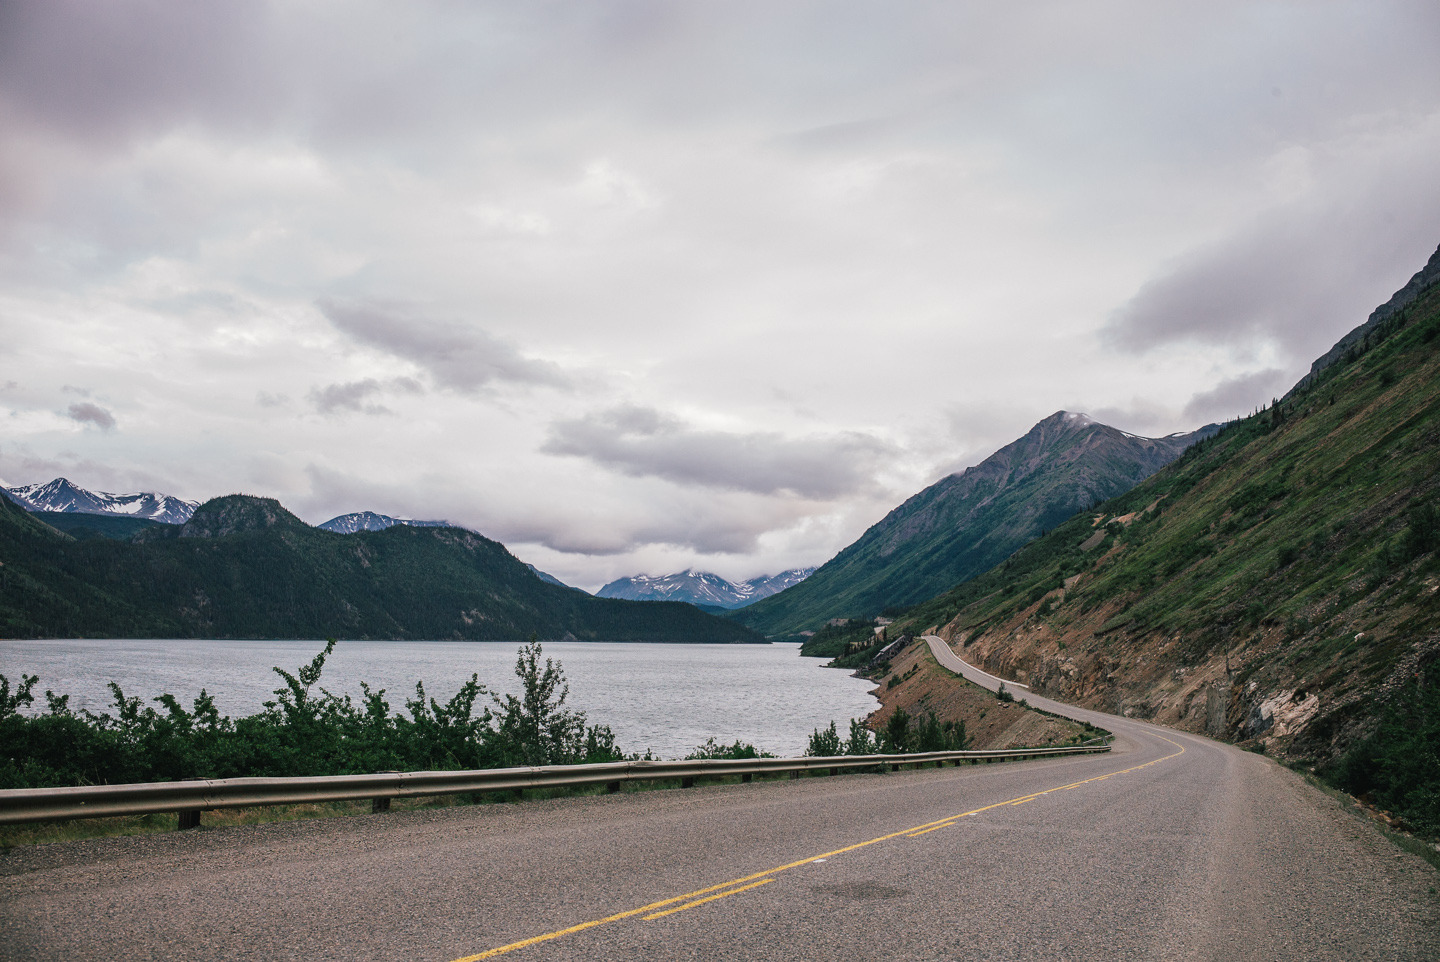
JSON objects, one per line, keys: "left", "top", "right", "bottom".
{"left": 733, "top": 410, "right": 1218, "bottom": 637}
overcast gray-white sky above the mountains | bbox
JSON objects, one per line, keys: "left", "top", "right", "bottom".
{"left": 0, "top": 0, "right": 1440, "bottom": 589}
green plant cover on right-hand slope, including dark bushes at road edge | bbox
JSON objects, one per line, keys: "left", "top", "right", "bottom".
{"left": 896, "top": 283, "right": 1440, "bottom": 834}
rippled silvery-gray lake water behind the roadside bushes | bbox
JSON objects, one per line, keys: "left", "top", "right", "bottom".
{"left": 0, "top": 639, "right": 878, "bottom": 758}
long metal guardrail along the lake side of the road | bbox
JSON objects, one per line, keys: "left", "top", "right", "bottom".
{"left": 0, "top": 745, "right": 1110, "bottom": 828}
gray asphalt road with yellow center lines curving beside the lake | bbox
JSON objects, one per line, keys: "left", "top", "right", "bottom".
{"left": 0, "top": 642, "right": 1440, "bottom": 962}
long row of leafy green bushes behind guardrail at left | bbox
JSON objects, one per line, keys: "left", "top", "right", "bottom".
{"left": 0, "top": 639, "right": 625, "bottom": 788}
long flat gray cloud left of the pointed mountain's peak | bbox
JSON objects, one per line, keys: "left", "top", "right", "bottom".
{"left": 540, "top": 406, "right": 894, "bottom": 500}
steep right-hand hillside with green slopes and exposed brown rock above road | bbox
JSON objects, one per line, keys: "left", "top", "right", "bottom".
{"left": 903, "top": 252, "right": 1440, "bottom": 785}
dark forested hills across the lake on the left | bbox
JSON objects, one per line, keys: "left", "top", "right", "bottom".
{"left": 0, "top": 495, "right": 759, "bottom": 642}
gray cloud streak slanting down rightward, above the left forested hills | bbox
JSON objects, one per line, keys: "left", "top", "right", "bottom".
{"left": 318, "top": 301, "right": 569, "bottom": 392}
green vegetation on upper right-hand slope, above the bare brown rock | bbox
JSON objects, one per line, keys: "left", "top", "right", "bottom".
{"left": 906, "top": 283, "right": 1440, "bottom": 662}
